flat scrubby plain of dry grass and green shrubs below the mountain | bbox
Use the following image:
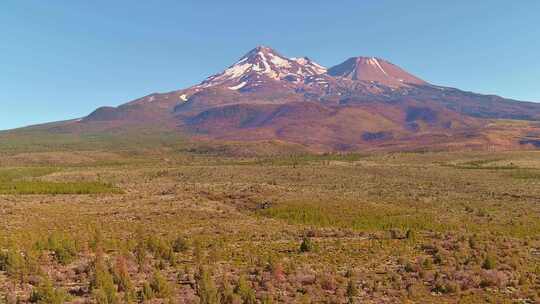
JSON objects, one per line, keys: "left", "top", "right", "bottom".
{"left": 0, "top": 143, "right": 540, "bottom": 303}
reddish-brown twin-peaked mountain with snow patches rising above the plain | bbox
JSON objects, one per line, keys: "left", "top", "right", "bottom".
{"left": 22, "top": 46, "right": 540, "bottom": 151}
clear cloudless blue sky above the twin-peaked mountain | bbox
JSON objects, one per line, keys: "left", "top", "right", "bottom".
{"left": 0, "top": 0, "right": 540, "bottom": 129}
